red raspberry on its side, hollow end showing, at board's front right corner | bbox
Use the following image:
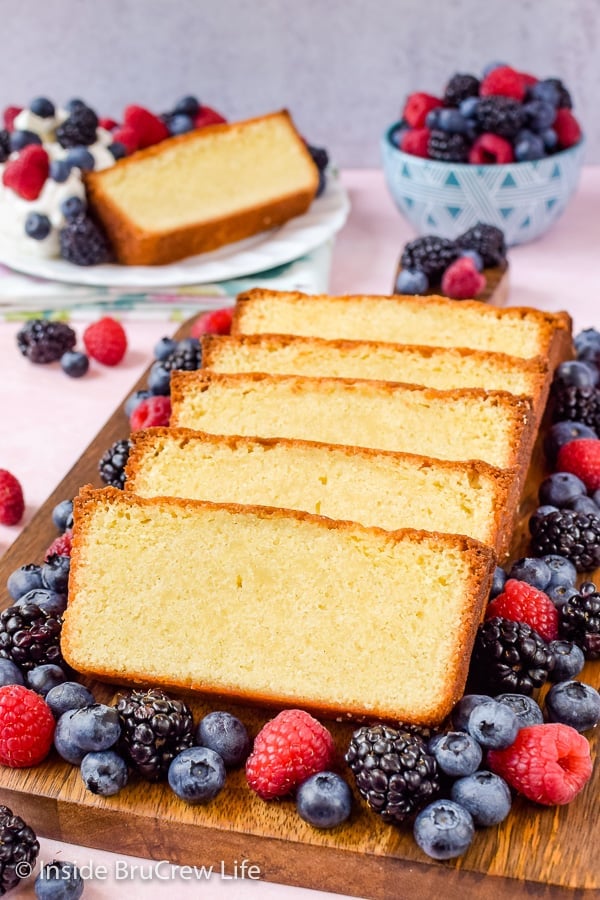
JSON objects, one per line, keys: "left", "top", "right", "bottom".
{"left": 487, "top": 723, "right": 592, "bottom": 806}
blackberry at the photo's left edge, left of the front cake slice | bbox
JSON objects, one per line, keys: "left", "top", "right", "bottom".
{"left": 0, "top": 603, "right": 66, "bottom": 673}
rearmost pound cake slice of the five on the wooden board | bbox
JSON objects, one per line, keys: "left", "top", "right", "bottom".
{"left": 231, "top": 288, "right": 573, "bottom": 371}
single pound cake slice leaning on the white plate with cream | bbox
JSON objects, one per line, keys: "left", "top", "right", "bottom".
{"left": 85, "top": 110, "right": 319, "bottom": 266}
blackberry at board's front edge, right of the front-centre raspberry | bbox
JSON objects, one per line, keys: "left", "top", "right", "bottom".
{"left": 346, "top": 725, "right": 440, "bottom": 824}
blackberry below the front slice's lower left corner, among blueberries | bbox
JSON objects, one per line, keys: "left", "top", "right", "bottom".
{"left": 117, "top": 688, "right": 194, "bottom": 781}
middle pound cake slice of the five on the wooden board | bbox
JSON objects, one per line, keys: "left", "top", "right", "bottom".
{"left": 171, "top": 369, "right": 535, "bottom": 471}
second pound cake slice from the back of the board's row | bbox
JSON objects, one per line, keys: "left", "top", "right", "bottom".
{"left": 202, "top": 334, "right": 551, "bottom": 422}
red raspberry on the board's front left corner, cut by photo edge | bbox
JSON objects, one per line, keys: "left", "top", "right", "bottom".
{"left": 0, "top": 684, "right": 54, "bottom": 769}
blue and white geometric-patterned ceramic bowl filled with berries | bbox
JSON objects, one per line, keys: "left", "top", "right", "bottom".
{"left": 381, "top": 122, "right": 584, "bottom": 245}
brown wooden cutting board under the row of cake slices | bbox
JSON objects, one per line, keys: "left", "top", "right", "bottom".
{"left": 0, "top": 323, "right": 600, "bottom": 900}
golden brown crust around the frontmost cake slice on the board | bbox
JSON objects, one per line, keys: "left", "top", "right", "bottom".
{"left": 61, "top": 485, "right": 495, "bottom": 725}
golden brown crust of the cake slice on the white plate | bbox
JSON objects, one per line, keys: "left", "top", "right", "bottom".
{"left": 84, "top": 110, "right": 319, "bottom": 266}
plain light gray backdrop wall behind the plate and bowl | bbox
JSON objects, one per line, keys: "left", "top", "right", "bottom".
{"left": 0, "top": 0, "right": 600, "bottom": 167}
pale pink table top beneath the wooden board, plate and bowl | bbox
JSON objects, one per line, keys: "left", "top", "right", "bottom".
{"left": 0, "top": 167, "right": 600, "bottom": 900}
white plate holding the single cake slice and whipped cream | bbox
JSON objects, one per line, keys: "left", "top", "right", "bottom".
{"left": 0, "top": 175, "right": 350, "bottom": 288}
